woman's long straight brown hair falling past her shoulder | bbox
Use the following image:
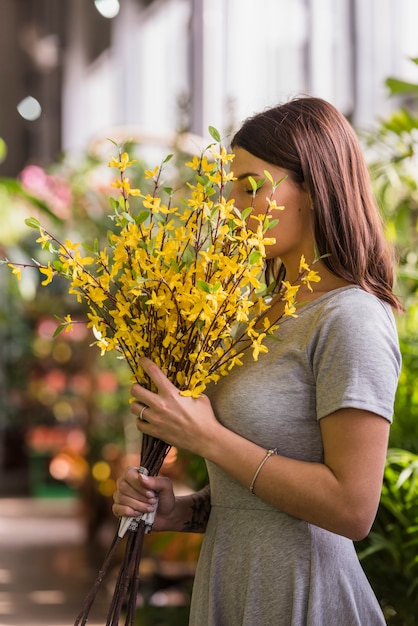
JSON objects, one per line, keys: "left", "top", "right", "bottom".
{"left": 232, "top": 97, "right": 403, "bottom": 311}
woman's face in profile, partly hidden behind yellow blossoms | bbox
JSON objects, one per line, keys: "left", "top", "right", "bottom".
{"left": 230, "top": 146, "right": 314, "bottom": 271}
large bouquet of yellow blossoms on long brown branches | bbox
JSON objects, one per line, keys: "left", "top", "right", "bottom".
{"left": 7, "top": 128, "right": 318, "bottom": 626}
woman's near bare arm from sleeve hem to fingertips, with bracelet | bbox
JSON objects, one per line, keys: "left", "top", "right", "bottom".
{"left": 131, "top": 359, "right": 389, "bottom": 540}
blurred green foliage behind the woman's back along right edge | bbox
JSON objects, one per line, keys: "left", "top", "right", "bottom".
{"left": 358, "top": 59, "right": 418, "bottom": 626}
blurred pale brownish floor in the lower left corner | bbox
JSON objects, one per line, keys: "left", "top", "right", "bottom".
{"left": 0, "top": 498, "right": 109, "bottom": 626}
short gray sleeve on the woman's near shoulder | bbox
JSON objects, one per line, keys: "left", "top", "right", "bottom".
{"left": 312, "top": 289, "right": 401, "bottom": 421}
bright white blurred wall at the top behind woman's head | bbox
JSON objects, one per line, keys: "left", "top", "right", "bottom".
{"left": 63, "top": 0, "right": 418, "bottom": 154}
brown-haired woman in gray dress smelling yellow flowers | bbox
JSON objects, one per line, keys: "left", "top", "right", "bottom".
{"left": 113, "top": 97, "right": 402, "bottom": 626}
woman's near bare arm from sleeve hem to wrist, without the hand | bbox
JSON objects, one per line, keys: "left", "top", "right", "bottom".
{"left": 204, "top": 409, "right": 389, "bottom": 541}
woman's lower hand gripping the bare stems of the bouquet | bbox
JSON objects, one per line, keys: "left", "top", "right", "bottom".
{"left": 112, "top": 467, "right": 176, "bottom": 531}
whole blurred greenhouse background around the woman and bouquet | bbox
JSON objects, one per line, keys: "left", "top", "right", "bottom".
{"left": 0, "top": 0, "right": 418, "bottom": 626}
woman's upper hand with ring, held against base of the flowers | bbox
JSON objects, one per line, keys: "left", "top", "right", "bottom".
{"left": 130, "top": 357, "right": 223, "bottom": 456}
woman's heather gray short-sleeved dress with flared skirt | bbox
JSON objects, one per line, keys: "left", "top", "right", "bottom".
{"left": 190, "top": 287, "right": 400, "bottom": 626}
